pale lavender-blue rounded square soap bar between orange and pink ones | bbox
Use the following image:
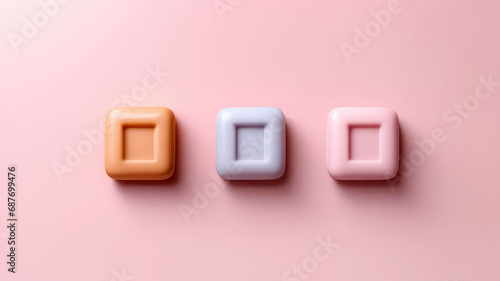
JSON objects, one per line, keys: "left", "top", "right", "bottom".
{"left": 216, "top": 107, "right": 286, "bottom": 180}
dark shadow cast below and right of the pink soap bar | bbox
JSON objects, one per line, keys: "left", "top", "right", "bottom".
{"left": 332, "top": 123, "right": 408, "bottom": 194}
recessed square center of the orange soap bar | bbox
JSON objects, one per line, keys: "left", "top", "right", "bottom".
{"left": 123, "top": 126, "right": 155, "bottom": 160}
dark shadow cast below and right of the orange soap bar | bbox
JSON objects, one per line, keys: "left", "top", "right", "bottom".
{"left": 114, "top": 120, "right": 184, "bottom": 191}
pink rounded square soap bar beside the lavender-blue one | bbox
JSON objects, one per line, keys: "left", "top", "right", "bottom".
{"left": 326, "top": 107, "right": 399, "bottom": 180}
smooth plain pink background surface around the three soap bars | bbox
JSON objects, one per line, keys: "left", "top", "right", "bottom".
{"left": 0, "top": 0, "right": 500, "bottom": 281}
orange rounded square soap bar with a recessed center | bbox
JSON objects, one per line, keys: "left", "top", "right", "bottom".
{"left": 104, "top": 107, "right": 175, "bottom": 180}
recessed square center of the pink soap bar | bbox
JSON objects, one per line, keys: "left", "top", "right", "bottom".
{"left": 349, "top": 125, "right": 380, "bottom": 160}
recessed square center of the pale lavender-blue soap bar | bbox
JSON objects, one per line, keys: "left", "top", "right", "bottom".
{"left": 236, "top": 126, "right": 265, "bottom": 160}
